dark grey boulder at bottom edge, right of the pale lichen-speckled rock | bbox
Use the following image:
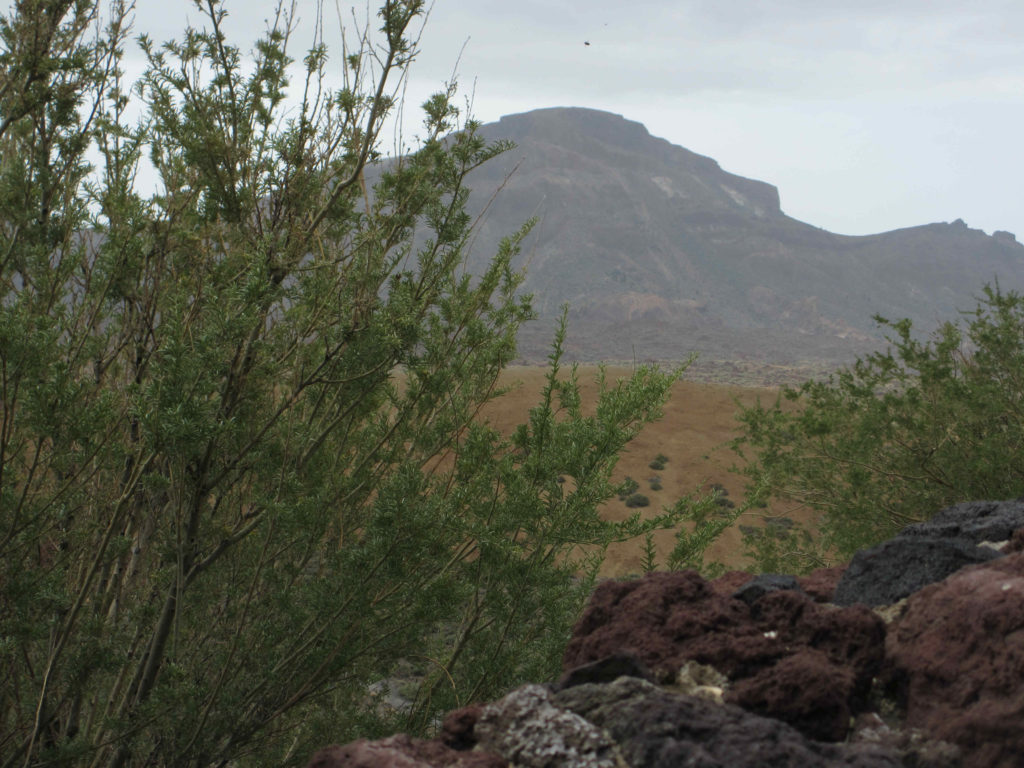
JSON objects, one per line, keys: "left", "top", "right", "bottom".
{"left": 551, "top": 677, "right": 901, "bottom": 768}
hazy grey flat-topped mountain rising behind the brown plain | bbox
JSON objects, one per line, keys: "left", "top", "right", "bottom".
{"left": 452, "top": 108, "right": 1024, "bottom": 364}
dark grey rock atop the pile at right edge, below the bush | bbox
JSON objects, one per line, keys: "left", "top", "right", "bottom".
{"left": 833, "top": 501, "right": 1024, "bottom": 605}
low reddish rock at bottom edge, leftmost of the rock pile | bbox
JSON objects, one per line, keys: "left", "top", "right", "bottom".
{"left": 307, "top": 734, "right": 508, "bottom": 768}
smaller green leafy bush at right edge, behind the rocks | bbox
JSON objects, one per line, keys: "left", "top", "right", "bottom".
{"left": 734, "top": 287, "right": 1024, "bottom": 568}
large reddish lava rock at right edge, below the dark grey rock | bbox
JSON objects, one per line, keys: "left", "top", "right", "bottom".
{"left": 886, "top": 553, "right": 1024, "bottom": 768}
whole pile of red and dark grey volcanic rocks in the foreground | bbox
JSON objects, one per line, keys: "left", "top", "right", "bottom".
{"left": 309, "top": 501, "right": 1024, "bottom": 768}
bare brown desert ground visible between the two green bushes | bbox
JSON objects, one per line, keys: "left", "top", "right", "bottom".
{"left": 484, "top": 366, "right": 802, "bottom": 578}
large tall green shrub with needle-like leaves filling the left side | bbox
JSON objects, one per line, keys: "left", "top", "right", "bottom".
{"left": 0, "top": 0, "right": 696, "bottom": 768}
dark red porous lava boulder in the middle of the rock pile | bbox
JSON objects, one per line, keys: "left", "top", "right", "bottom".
{"left": 563, "top": 571, "right": 885, "bottom": 740}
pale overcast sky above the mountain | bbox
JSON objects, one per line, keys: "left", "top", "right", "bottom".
{"left": 130, "top": 0, "right": 1024, "bottom": 241}
